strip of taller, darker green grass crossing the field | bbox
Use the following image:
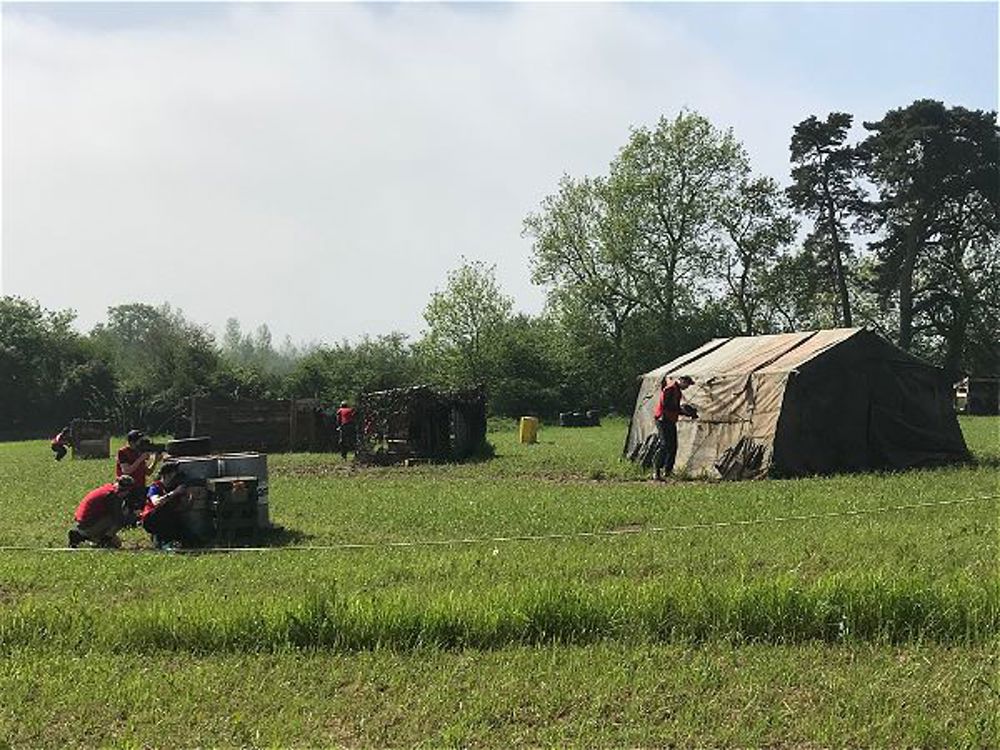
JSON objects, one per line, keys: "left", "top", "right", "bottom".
{"left": 0, "top": 575, "right": 1000, "bottom": 654}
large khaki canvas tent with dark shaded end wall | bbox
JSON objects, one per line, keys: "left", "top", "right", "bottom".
{"left": 625, "top": 328, "right": 969, "bottom": 478}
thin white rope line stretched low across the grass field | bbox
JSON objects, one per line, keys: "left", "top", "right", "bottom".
{"left": 0, "top": 493, "right": 1000, "bottom": 555}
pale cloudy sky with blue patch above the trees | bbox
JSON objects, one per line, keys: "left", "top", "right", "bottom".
{"left": 0, "top": 3, "right": 998, "bottom": 344}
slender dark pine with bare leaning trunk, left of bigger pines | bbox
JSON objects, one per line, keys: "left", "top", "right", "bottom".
{"left": 788, "top": 112, "right": 864, "bottom": 327}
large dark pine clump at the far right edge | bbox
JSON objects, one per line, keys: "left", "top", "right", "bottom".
{"left": 862, "top": 99, "right": 1000, "bottom": 368}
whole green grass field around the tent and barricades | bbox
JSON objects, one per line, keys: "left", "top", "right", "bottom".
{"left": 0, "top": 417, "right": 1000, "bottom": 747}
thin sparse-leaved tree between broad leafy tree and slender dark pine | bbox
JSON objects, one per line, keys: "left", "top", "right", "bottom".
{"left": 714, "top": 177, "right": 797, "bottom": 336}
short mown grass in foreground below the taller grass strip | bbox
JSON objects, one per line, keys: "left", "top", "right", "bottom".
{"left": 0, "top": 643, "right": 1000, "bottom": 748}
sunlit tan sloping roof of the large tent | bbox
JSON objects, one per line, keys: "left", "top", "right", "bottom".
{"left": 643, "top": 328, "right": 864, "bottom": 380}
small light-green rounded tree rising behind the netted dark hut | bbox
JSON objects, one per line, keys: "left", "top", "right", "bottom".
{"left": 421, "top": 261, "right": 513, "bottom": 384}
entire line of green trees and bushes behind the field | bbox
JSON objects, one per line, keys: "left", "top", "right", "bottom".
{"left": 0, "top": 100, "right": 1000, "bottom": 436}
